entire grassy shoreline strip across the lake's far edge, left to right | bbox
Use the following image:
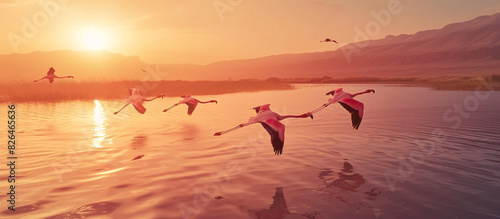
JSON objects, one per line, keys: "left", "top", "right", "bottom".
{"left": 0, "top": 74, "right": 500, "bottom": 102}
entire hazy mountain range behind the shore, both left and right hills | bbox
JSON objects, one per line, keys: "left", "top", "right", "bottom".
{"left": 0, "top": 13, "right": 500, "bottom": 81}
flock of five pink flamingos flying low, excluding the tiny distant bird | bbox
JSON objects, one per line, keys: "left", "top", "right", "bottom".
{"left": 34, "top": 68, "right": 375, "bottom": 155}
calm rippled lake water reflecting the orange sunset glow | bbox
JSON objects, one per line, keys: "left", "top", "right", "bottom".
{"left": 0, "top": 85, "right": 500, "bottom": 219}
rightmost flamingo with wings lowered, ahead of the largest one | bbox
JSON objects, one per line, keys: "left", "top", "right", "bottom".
{"left": 310, "top": 88, "right": 375, "bottom": 130}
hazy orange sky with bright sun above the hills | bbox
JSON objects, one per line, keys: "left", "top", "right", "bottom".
{"left": 0, "top": 0, "right": 500, "bottom": 64}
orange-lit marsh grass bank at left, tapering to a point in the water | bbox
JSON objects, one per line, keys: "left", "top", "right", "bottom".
{"left": 0, "top": 80, "right": 294, "bottom": 102}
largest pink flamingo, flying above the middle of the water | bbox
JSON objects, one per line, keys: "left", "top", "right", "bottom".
{"left": 214, "top": 104, "right": 313, "bottom": 155}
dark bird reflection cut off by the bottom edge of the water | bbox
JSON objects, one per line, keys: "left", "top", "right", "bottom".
{"left": 249, "top": 187, "right": 316, "bottom": 219}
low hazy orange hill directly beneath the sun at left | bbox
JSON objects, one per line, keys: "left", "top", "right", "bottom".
{"left": 0, "top": 50, "right": 147, "bottom": 82}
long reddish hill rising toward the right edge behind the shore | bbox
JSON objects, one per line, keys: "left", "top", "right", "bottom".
{"left": 162, "top": 13, "right": 500, "bottom": 80}
